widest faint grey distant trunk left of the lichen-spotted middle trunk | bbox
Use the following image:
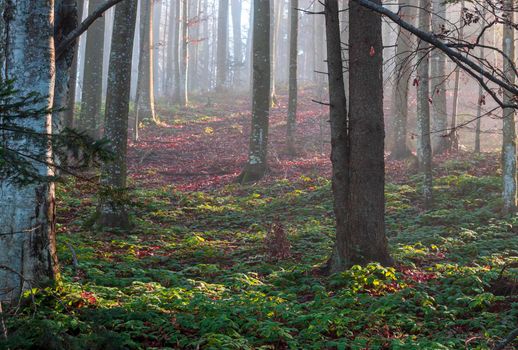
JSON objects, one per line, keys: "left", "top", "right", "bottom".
{"left": 216, "top": 0, "right": 228, "bottom": 90}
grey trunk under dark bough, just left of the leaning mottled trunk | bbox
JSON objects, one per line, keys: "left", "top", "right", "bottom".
{"left": 79, "top": 0, "right": 105, "bottom": 138}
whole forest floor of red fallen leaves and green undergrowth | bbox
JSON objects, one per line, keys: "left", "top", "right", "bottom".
{"left": 0, "top": 93, "right": 518, "bottom": 350}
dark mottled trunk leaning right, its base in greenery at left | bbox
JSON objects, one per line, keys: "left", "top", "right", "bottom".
{"left": 98, "top": 0, "right": 138, "bottom": 228}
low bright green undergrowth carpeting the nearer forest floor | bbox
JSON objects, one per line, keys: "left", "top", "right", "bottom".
{"left": 0, "top": 161, "right": 518, "bottom": 349}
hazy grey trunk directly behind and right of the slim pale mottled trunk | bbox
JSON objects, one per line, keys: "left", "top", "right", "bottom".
{"left": 430, "top": 0, "right": 448, "bottom": 154}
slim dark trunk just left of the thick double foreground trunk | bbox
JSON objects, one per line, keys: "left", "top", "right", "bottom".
{"left": 286, "top": 0, "right": 299, "bottom": 155}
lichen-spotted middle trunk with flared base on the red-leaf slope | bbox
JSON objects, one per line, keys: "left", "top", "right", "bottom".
{"left": 238, "top": 0, "right": 271, "bottom": 182}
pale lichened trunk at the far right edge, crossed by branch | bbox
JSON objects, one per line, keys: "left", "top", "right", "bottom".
{"left": 502, "top": 0, "right": 516, "bottom": 214}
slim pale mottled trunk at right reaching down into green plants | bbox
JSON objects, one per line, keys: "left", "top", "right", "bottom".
{"left": 417, "top": 0, "right": 432, "bottom": 209}
